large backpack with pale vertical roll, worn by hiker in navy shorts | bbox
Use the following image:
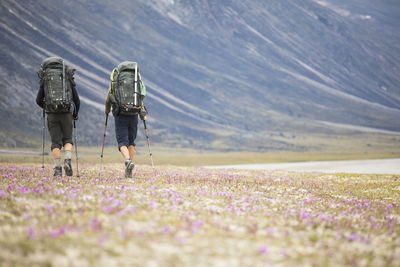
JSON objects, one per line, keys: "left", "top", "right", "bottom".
{"left": 111, "top": 61, "right": 142, "bottom": 115}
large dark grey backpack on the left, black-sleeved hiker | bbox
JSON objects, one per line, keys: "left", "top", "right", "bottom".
{"left": 38, "top": 57, "right": 75, "bottom": 113}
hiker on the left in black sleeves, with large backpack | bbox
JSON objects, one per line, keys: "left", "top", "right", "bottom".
{"left": 36, "top": 57, "right": 80, "bottom": 176}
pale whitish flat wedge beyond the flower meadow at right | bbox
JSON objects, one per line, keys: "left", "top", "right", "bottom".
{"left": 206, "top": 159, "right": 400, "bottom": 174}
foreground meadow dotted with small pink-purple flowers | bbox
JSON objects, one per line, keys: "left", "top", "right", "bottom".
{"left": 0, "top": 164, "right": 400, "bottom": 266}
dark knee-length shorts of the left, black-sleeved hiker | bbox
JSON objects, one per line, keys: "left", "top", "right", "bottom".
{"left": 47, "top": 112, "right": 73, "bottom": 150}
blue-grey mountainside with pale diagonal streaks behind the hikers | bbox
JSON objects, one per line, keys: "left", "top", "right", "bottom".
{"left": 0, "top": 0, "right": 400, "bottom": 150}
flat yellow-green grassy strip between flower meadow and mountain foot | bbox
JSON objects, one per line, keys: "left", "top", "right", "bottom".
{"left": 0, "top": 147, "right": 400, "bottom": 166}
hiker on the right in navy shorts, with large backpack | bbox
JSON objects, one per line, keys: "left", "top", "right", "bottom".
{"left": 105, "top": 61, "right": 147, "bottom": 178}
